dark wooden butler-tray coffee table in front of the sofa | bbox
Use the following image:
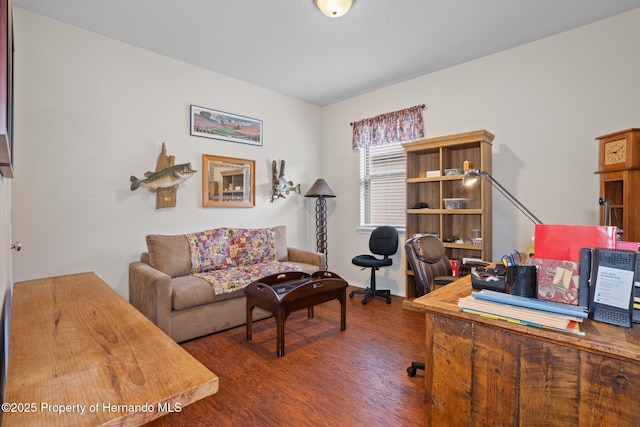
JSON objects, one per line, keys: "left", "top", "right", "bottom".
{"left": 244, "top": 271, "right": 347, "bottom": 357}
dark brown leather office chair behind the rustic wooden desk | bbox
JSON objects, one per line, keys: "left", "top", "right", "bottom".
{"left": 404, "top": 236, "right": 458, "bottom": 377}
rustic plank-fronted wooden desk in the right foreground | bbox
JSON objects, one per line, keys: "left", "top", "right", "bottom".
{"left": 413, "top": 276, "right": 640, "bottom": 427}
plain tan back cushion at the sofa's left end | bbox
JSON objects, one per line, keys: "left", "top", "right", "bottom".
{"left": 146, "top": 234, "right": 191, "bottom": 277}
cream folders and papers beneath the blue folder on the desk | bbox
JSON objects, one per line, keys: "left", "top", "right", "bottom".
{"left": 458, "top": 291, "right": 584, "bottom": 335}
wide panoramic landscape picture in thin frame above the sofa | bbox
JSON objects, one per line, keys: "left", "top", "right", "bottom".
{"left": 190, "top": 105, "right": 262, "bottom": 147}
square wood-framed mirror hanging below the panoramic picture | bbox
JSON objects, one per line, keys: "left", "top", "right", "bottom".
{"left": 202, "top": 154, "right": 256, "bottom": 208}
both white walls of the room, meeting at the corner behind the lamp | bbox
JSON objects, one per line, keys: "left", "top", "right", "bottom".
{"left": 12, "top": 8, "right": 640, "bottom": 297}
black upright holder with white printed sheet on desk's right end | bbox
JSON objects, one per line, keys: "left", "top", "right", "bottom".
{"left": 581, "top": 248, "right": 638, "bottom": 327}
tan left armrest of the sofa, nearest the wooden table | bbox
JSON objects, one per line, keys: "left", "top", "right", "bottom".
{"left": 129, "top": 262, "right": 171, "bottom": 336}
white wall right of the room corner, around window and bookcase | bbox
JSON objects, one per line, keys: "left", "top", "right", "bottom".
{"left": 323, "top": 9, "right": 640, "bottom": 295}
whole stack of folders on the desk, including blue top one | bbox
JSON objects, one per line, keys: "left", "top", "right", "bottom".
{"left": 458, "top": 289, "right": 588, "bottom": 335}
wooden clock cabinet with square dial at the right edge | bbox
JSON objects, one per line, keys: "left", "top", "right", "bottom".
{"left": 596, "top": 129, "right": 640, "bottom": 242}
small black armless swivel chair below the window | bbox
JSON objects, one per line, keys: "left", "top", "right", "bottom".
{"left": 349, "top": 225, "right": 398, "bottom": 305}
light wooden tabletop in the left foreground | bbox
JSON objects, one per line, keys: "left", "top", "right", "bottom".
{"left": 3, "top": 273, "right": 218, "bottom": 427}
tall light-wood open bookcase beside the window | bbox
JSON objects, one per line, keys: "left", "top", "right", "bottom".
{"left": 403, "top": 130, "right": 494, "bottom": 309}
